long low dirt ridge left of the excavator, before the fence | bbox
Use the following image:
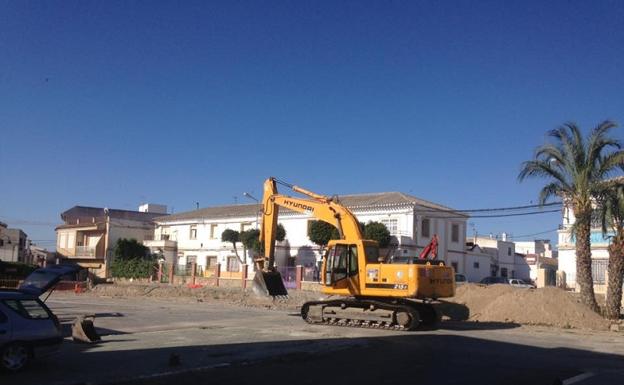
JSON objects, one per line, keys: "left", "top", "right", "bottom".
{"left": 89, "top": 284, "right": 322, "bottom": 311}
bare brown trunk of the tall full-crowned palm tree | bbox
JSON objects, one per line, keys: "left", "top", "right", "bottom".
{"left": 576, "top": 211, "right": 600, "bottom": 312}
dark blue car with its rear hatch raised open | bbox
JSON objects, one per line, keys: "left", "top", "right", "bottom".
{"left": 0, "top": 265, "right": 77, "bottom": 372}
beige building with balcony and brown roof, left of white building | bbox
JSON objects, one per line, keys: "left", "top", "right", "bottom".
{"left": 56, "top": 206, "right": 166, "bottom": 278}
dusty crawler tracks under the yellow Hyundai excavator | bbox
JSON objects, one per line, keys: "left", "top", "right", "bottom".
{"left": 301, "top": 298, "right": 438, "bottom": 331}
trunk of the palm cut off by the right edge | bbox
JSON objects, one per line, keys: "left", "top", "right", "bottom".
{"left": 605, "top": 228, "right": 624, "bottom": 319}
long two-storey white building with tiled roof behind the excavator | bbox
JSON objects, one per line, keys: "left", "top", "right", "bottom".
{"left": 145, "top": 192, "right": 468, "bottom": 273}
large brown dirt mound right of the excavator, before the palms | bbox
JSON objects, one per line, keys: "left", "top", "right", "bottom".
{"left": 448, "top": 284, "right": 609, "bottom": 330}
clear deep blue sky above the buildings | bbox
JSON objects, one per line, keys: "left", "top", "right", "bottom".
{"left": 0, "top": 0, "right": 624, "bottom": 249}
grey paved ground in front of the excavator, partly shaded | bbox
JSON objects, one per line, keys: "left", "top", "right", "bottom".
{"left": 6, "top": 294, "right": 624, "bottom": 385}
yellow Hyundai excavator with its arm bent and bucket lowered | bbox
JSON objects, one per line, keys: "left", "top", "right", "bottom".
{"left": 252, "top": 178, "right": 455, "bottom": 330}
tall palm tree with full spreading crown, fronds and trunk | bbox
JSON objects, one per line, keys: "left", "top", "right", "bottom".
{"left": 518, "top": 121, "right": 624, "bottom": 311}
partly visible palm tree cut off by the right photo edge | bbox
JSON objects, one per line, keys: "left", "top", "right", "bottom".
{"left": 599, "top": 183, "right": 624, "bottom": 319}
